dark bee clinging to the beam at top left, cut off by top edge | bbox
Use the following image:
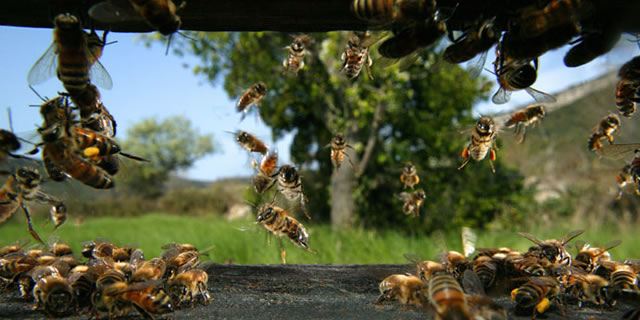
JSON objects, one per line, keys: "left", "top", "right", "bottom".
{"left": 89, "top": 0, "right": 186, "bottom": 36}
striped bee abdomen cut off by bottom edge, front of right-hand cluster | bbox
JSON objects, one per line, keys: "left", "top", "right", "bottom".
{"left": 429, "top": 273, "right": 471, "bottom": 320}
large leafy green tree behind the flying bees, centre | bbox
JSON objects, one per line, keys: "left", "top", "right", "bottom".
{"left": 162, "top": 32, "right": 523, "bottom": 229}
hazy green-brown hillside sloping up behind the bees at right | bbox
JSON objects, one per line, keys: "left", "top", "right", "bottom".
{"left": 495, "top": 73, "right": 640, "bottom": 220}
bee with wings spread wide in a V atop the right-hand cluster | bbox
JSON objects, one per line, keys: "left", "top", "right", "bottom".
{"left": 518, "top": 230, "right": 584, "bottom": 266}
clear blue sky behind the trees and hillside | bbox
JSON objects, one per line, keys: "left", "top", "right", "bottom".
{"left": 0, "top": 26, "right": 638, "bottom": 180}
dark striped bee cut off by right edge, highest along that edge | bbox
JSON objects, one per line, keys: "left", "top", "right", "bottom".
{"left": 616, "top": 56, "right": 640, "bottom": 118}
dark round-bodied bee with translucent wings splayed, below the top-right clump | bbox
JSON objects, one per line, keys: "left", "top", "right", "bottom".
{"left": 491, "top": 45, "right": 556, "bottom": 104}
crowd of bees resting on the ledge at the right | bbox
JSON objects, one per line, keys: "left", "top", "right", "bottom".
{"left": 375, "top": 229, "right": 640, "bottom": 319}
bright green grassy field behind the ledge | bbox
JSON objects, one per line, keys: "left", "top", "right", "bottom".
{"left": 0, "top": 214, "right": 640, "bottom": 264}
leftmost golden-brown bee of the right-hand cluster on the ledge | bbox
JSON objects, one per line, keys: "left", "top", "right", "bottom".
{"left": 376, "top": 274, "right": 426, "bottom": 310}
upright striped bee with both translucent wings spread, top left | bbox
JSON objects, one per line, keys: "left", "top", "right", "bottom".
{"left": 27, "top": 13, "right": 113, "bottom": 96}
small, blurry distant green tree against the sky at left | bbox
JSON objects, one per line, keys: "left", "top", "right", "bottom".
{"left": 118, "top": 116, "right": 214, "bottom": 197}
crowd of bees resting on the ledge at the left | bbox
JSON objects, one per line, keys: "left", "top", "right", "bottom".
{"left": 0, "top": 238, "right": 213, "bottom": 319}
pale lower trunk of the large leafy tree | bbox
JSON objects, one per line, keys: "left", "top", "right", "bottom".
{"left": 331, "top": 149, "right": 357, "bottom": 230}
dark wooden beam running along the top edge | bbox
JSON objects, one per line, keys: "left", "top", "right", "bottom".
{"left": 0, "top": 0, "right": 367, "bottom": 32}
